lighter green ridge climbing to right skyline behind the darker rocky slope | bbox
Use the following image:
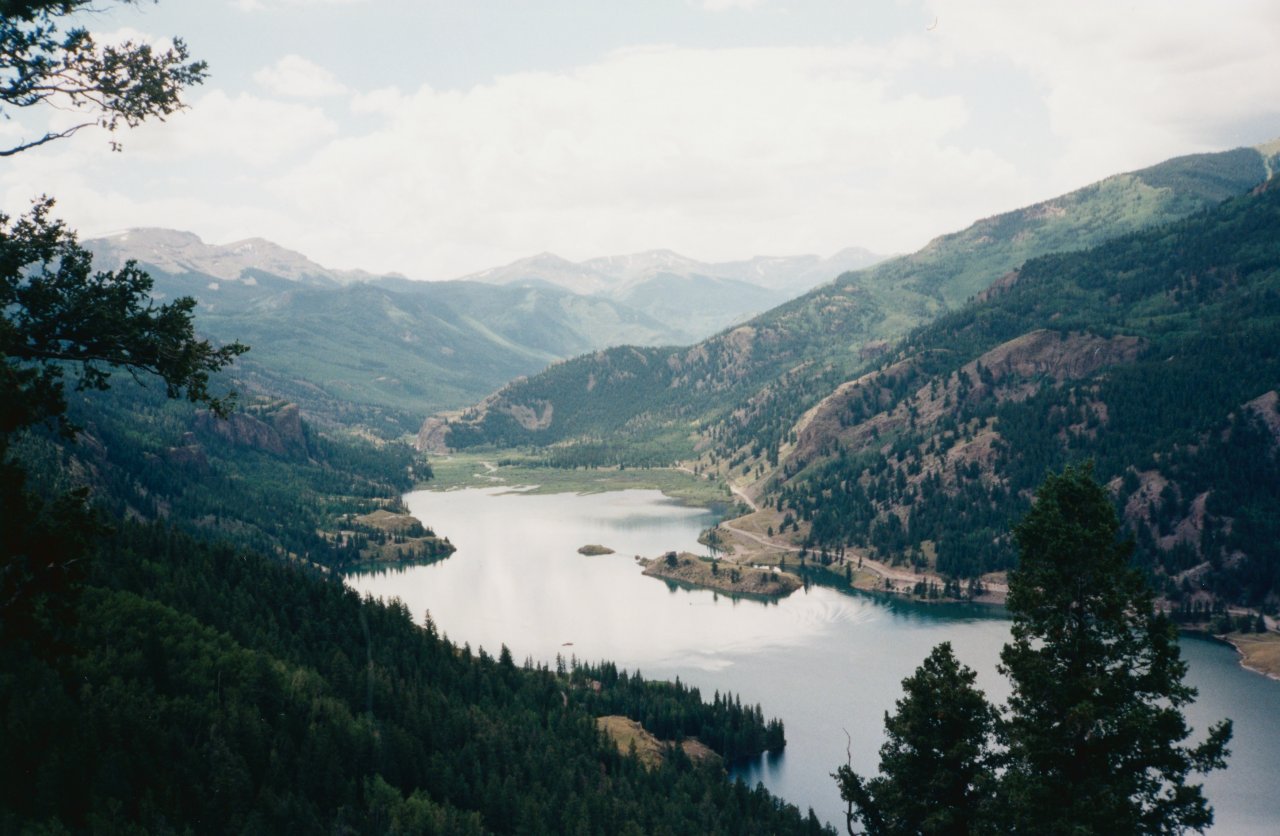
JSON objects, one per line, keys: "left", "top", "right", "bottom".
{"left": 432, "top": 147, "right": 1276, "bottom": 463}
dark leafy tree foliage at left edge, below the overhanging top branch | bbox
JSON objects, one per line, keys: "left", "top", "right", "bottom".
{"left": 0, "top": 198, "right": 247, "bottom": 639}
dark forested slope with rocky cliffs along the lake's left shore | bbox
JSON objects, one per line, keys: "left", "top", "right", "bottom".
{"left": 14, "top": 375, "right": 452, "bottom": 571}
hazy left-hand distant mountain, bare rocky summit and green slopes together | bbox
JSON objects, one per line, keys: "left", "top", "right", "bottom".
{"left": 87, "top": 240, "right": 685, "bottom": 435}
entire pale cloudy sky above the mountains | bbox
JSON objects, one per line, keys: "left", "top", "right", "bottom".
{"left": 0, "top": 0, "right": 1280, "bottom": 279}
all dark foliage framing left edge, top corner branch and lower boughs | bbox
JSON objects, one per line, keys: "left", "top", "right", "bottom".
{"left": 0, "top": 0, "right": 231, "bottom": 643}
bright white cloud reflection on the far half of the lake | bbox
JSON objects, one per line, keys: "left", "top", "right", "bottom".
{"left": 348, "top": 488, "right": 858, "bottom": 670}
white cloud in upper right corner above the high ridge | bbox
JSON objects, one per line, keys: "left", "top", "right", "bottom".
{"left": 931, "top": 0, "right": 1280, "bottom": 185}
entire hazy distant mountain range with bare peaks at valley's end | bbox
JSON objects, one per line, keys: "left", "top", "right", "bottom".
{"left": 86, "top": 228, "right": 873, "bottom": 434}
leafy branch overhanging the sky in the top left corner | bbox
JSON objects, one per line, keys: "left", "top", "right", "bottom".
{"left": 0, "top": 0, "right": 207, "bottom": 156}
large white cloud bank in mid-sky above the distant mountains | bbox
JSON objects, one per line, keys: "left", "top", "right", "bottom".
{"left": 264, "top": 47, "right": 1016, "bottom": 277}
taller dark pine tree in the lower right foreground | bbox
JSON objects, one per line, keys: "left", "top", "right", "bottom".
{"left": 1000, "top": 465, "right": 1231, "bottom": 835}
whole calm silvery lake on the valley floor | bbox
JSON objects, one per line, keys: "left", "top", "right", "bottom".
{"left": 347, "top": 488, "right": 1280, "bottom": 836}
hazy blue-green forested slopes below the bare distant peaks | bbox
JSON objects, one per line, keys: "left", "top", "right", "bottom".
{"left": 190, "top": 280, "right": 672, "bottom": 435}
